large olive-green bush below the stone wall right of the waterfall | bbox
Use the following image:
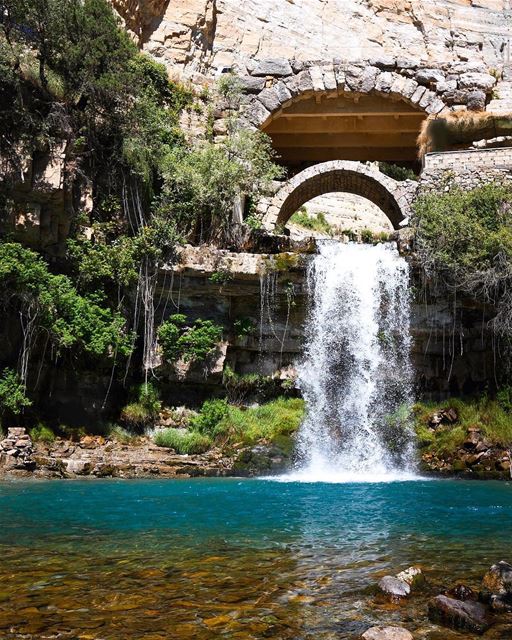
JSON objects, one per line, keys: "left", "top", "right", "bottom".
{"left": 412, "top": 183, "right": 512, "bottom": 336}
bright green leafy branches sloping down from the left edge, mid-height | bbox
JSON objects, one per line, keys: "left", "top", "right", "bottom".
{"left": 0, "top": 243, "right": 131, "bottom": 358}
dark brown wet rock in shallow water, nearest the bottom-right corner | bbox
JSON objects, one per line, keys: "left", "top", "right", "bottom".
{"left": 428, "top": 595, "right": 490, "bottom": 634}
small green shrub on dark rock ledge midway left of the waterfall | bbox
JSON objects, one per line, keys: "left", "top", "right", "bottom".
{"left": 158, "top": 314, "right": 222, "bottom": 362}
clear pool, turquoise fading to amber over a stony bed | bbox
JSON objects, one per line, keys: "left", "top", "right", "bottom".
{"left": 0, "top": 479, "right": 512, "bottom": 640}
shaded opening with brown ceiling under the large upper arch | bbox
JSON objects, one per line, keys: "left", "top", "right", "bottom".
{"left": 262, "top": 92, "right": 426, "bottom": 173}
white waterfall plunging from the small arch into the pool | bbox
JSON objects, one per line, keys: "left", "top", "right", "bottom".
{"left": 288, "top": 241, "right": 414, "bottom": 482}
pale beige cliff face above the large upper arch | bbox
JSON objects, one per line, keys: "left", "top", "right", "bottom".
{"left": 120, "top": 0, "right": 508, "bottom": 82}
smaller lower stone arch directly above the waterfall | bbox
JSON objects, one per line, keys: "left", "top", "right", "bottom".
{"left": 259, "top": 160, "right": 417, "bottom": 231}
